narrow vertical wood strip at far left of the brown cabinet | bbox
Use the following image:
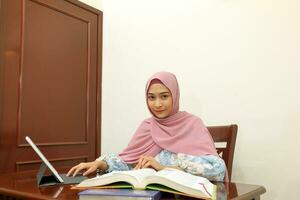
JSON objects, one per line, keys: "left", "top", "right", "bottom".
{"left": 0, "top": 0, "right": 22, "bottom": 175}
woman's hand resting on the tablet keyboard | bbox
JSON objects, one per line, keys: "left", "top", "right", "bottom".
{"left": 67, "top": 160, "right": 107, "bottom": 176}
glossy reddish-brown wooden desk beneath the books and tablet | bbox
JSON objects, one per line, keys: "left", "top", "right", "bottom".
{"left": 0, "top": 171, "right": 266, "bottom": 200}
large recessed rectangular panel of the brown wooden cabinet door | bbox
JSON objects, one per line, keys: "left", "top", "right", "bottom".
{"left": 18, "top": 1, "right": 89, "bottom": 143}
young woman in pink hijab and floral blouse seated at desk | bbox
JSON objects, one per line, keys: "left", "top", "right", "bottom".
{"left": 68, "top": 72, "right": 226, "bottom": 181}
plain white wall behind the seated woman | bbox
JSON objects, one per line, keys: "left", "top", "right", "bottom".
{"left": 81, "top": 0, "right": 300, "bottom": 200}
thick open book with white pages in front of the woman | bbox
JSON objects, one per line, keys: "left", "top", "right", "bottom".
{"left": 76, "top": 168, "right": 217, "bottom": 199}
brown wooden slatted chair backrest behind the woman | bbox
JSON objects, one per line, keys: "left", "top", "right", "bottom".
{"left": 207, "top": 124, "right": 238, "bottom": 181}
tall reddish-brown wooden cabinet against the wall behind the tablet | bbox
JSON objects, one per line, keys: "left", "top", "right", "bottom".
{"left": 0, "top": 0, "right": 102, "bottom": 173}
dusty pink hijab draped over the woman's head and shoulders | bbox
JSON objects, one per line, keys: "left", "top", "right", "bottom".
{"left": 119, "top": 72, "right": 218, "bottom": 164}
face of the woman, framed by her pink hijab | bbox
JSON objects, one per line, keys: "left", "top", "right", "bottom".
{"left": 147, "top": 83, "right": 173, "bottom": 119}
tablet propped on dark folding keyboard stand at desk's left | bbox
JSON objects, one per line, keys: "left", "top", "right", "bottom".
{"left": 25, "top": 136, "right": 87, "bottom": 186}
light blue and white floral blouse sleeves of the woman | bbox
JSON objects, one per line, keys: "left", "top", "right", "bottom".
{"left": 97, "top": 150, "right": 226, "bottom": 181}
